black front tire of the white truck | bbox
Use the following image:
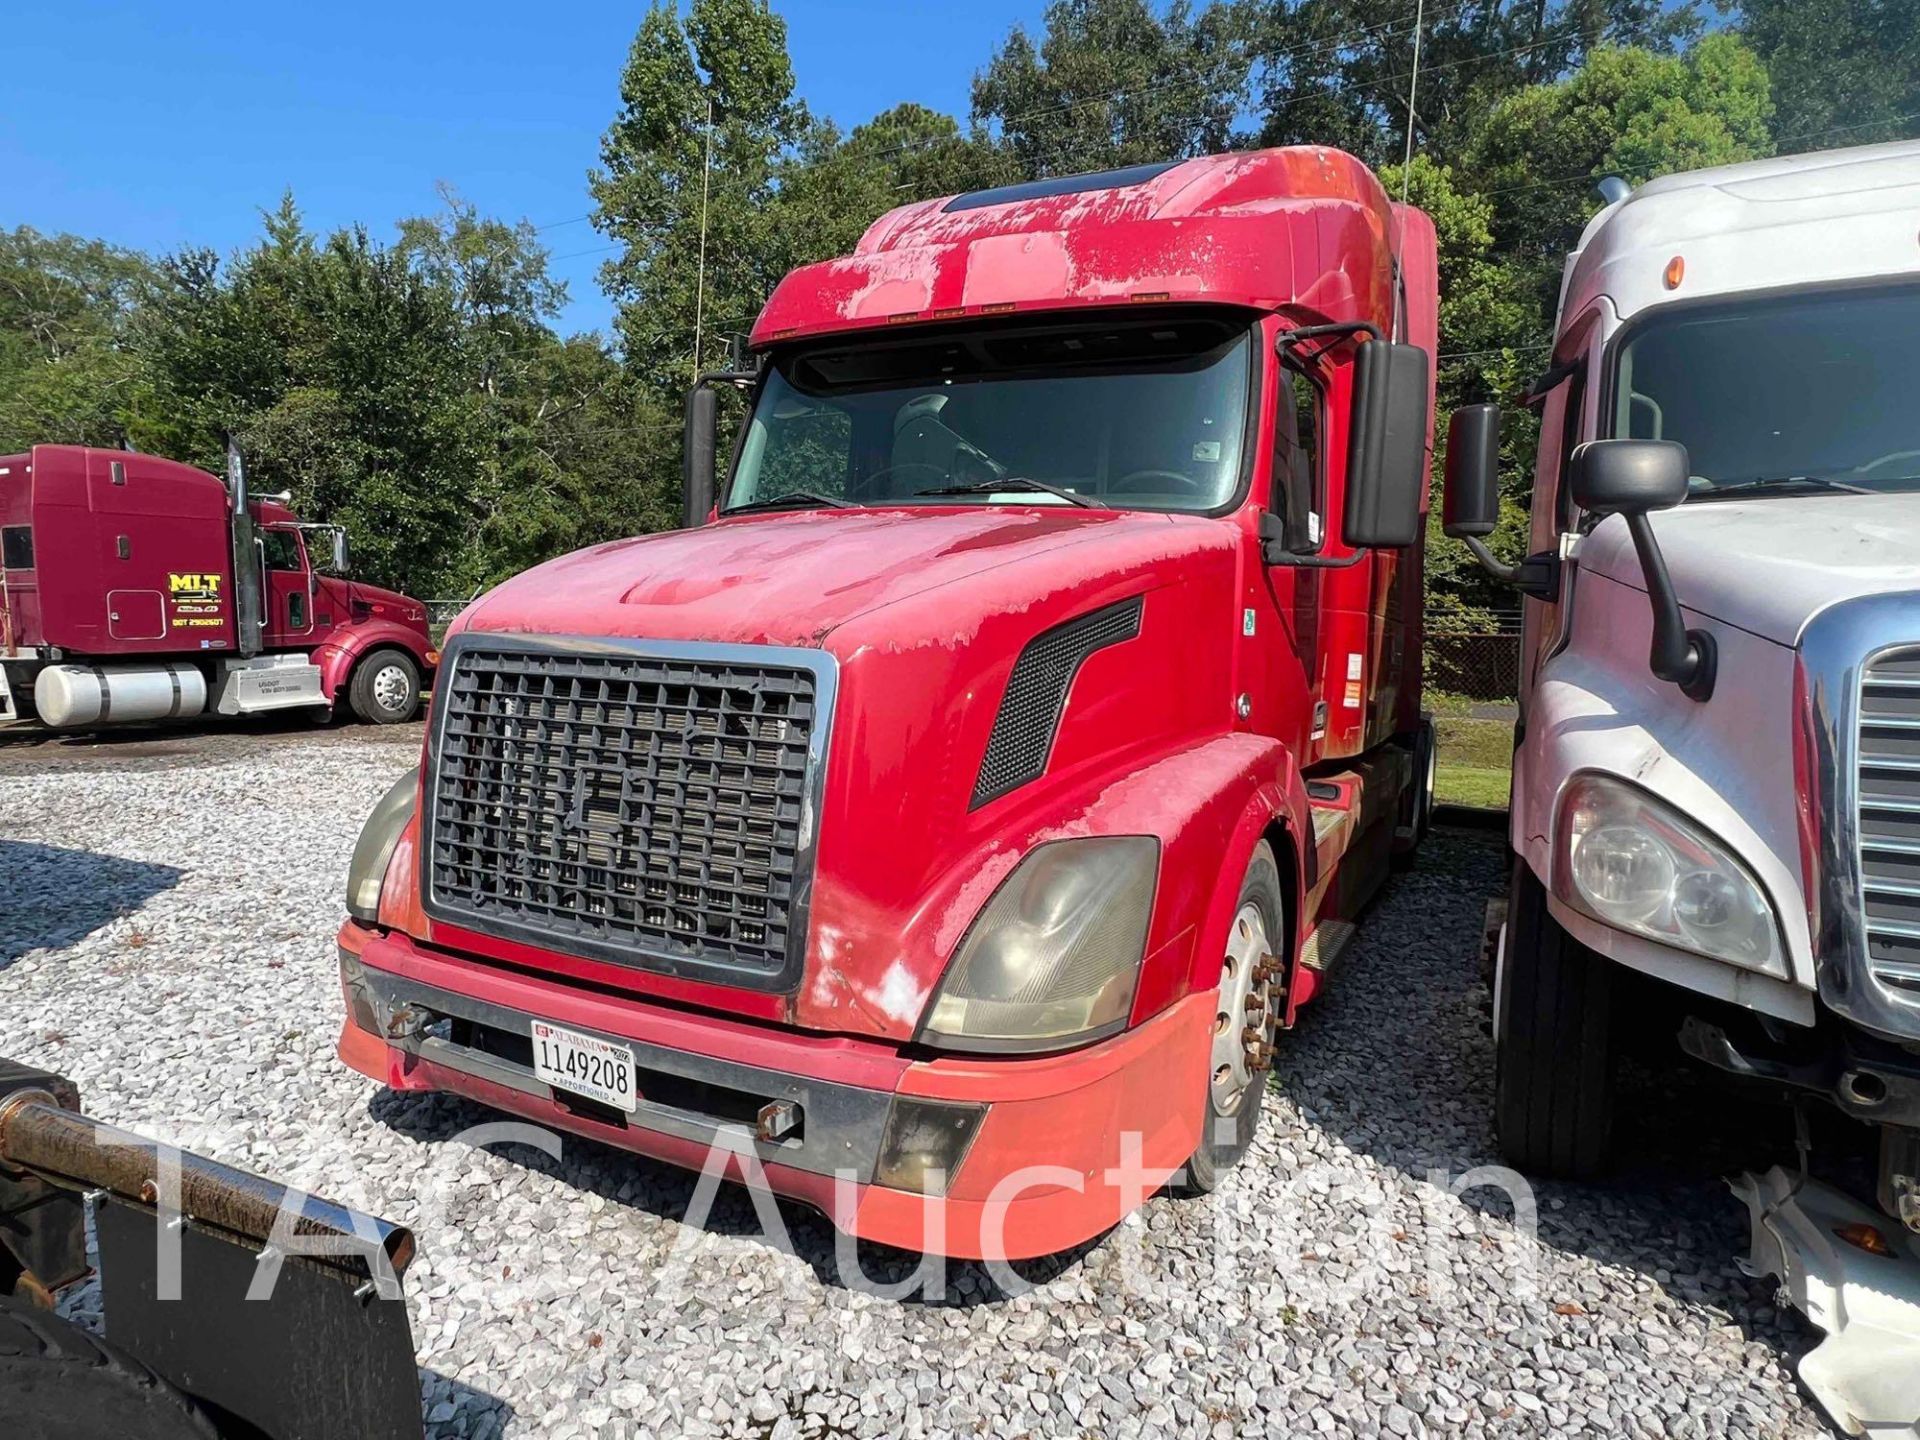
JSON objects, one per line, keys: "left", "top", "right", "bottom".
{"left": 1494, "top": 860, "right": 1613, "bottom": 1181}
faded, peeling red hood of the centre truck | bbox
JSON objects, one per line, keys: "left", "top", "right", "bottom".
{"left": 441, "top": 505, "right": 1240, "bottom": 1041}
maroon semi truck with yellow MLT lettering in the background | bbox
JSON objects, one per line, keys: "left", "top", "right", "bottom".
{"left": 0, "top": 445, "right": 440, "bottom": 730}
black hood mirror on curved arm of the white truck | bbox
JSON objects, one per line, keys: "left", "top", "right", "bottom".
{"left": 1567, "top": 440, "right": 1716, "bottom": 701}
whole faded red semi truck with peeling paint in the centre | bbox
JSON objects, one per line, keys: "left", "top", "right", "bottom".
{"left": 340, "top": 148, "right": 1436, "bottom": 1260}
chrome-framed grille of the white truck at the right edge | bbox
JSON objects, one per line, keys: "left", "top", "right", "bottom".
{"left": 1799, "top": 591, "right": 1920, "bottom": 1041}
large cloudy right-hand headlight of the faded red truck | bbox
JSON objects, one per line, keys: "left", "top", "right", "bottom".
{"left": 920, "top": 835, "right": 1160, "bottom": 1050}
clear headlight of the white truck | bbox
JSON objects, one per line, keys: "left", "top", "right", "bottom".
{"left": 1553, "top": 774, "right": 1788, "bottom": 977}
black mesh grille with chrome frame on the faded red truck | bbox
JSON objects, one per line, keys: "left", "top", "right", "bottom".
{"left": 424, "top": 636, "right": 833, "bottom": 989}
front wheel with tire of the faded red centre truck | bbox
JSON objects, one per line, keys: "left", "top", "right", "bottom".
{"left": 1179, "top": 841, "right": 1286, "bottom": 1194}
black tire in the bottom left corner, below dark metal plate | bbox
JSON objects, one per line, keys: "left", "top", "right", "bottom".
{"left": 0, "top": 1298, "right": 219, "bottom": 1440}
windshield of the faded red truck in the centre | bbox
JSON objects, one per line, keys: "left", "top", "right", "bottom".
{"left": 724, "top": 317, "right": 1252, "bottom": 511}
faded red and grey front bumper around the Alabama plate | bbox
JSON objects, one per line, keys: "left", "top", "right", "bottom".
{"left": 340, "top": 922, "right": 1213, "bottom": 1260}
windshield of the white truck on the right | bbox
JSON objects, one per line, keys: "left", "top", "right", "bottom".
{"left": 1613, "top": 286, "right": 1920, "bottom": 499}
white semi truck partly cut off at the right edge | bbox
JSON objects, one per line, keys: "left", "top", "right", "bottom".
{"left": 1446, "top": 144, "right": 1920, "bottom": 1434}
